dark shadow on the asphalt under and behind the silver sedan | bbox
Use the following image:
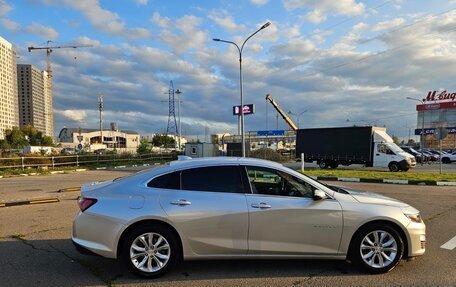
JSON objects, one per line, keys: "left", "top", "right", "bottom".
{"left": 0, "top": 235, "right": 365, "bottom": 286}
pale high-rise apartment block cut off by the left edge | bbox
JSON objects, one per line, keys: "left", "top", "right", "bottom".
{"left": 0, "top": 37, "right": 19, "bottom": 139}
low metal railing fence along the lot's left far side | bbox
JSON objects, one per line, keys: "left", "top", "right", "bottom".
{"left": 0, "top": 153, "right": 177, "bottom": 170}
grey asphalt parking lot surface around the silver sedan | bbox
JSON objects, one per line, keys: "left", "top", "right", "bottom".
{"left": 0, "top": 171, "right": 456, "bottom": 286}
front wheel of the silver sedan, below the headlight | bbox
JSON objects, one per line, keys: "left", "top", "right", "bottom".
{"left": 350, "top": 223, "right": 404, "bottom": 274}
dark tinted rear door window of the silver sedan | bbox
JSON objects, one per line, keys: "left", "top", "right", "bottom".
{"left": 182, "top": 166, "right": 244, "bottom": 193}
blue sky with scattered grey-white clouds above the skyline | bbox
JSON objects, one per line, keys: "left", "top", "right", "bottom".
{"left": 0, "top": 0, "right": 456, "bottom": 140}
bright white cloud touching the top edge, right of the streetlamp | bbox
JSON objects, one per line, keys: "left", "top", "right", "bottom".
{"left": 283, "top": 0, "right": 365, "bottom": 23}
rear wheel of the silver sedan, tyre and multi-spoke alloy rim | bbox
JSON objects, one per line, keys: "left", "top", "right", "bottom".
{"left": 121, "top": 224, "right": 180, "bottom": 278}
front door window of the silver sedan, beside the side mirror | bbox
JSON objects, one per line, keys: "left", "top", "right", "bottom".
{"left": 247, "top": 166, "right": 315, "bottom": 198}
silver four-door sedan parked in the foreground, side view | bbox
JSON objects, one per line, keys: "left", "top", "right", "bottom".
{"left": 72, "top": 157, "right": 426, "bottom": 277}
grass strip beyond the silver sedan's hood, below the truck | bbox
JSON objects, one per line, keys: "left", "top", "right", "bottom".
{"left": 304, "top": 169, "right": 456, "bottom": 182}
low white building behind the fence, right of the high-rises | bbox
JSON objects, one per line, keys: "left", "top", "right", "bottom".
{"left": 58, "top": 128, "right": 140, "bottom": 153}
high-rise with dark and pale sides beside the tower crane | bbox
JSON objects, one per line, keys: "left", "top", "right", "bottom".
{"left": 17, "top": 64, "right": 54, "bottom": 138}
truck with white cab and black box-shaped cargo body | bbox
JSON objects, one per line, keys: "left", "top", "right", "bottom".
{"left": 296, "top": 126, "right": 416, "bottom": 172}
